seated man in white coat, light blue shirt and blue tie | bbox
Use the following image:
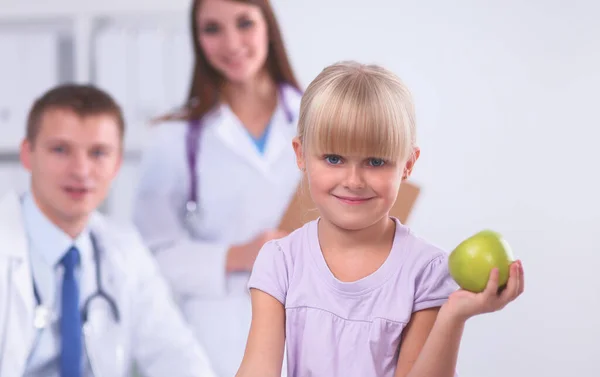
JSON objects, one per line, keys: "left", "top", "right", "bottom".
{"left": 0, "top": 85, "right": 215, "bottom": 377}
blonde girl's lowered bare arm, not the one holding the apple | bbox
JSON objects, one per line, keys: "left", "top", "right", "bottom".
{"left": 236, "top": 289, "right": 285, "bottom": 377}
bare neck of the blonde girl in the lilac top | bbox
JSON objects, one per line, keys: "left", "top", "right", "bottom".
{"left": 318, "top": 216, "right": 396, "bottom": 252}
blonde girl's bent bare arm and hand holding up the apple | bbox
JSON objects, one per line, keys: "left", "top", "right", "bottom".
{"left": 395, "top": 261, "right": 525, "bottom": 377}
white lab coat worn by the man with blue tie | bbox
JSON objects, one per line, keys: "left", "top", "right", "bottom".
{"left": 0, "top": 193, "right": 215, "bottom": 377}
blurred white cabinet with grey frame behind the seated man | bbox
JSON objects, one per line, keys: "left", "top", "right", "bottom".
{"left": 0, "top": 5, "right": 193, "bottom": 219}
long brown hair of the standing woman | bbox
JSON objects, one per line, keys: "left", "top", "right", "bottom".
{"left": 158, "top": 0, "right": 300, "bottom": 121}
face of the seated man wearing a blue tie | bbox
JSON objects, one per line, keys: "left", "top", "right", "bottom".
{"left": 21, "top": 108, "right": 122, "bottom": 232}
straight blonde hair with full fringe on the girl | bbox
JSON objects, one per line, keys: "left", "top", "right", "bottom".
{"left": 298, "top": 61, "right": 416, "bottom": 162}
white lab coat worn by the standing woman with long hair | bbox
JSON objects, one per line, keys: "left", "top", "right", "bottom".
{"left": 134, "top": 83, "right": 301, "bottom": 377}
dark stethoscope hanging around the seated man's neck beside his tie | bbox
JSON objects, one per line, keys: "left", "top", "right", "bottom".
{"left": 33, "top": 234, "right": 121, "bottom": 330}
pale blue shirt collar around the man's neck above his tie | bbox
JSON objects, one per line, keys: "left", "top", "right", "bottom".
{"left": 23, "top": 192, "right": 92, "bottom": 267}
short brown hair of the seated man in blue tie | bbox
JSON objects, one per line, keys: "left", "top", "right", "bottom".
{"left": 25, "top": 84, "right": 125, "bottom": 145}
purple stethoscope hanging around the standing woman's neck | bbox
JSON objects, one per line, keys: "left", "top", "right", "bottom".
{"left": 185, "top": 84, "right": 301, "bottom": 224}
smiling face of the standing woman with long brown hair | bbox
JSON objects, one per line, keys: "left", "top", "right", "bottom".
{"left": 196, "top": 0, "right": 269, "bottom": 83}
